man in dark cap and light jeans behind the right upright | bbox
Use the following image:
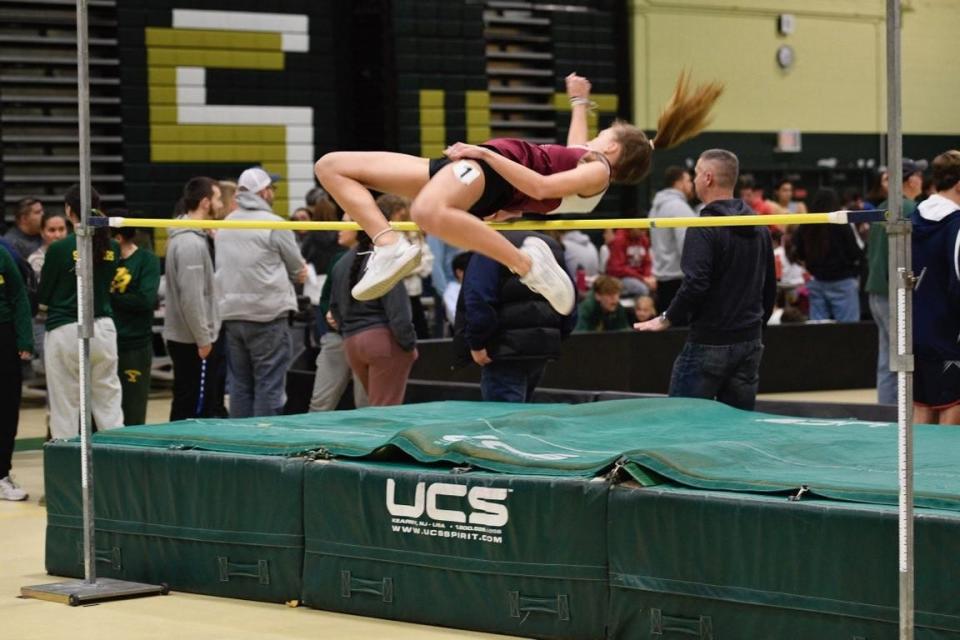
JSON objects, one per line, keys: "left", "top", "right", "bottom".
{"left": 863, "top": 158, "right": 926, "bottom": 404}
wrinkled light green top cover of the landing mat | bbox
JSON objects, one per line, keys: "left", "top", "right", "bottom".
{"left": 94, "top": 398, "right": 960, "bottom": 510}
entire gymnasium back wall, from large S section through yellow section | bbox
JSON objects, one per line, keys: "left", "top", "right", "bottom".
{"left": 101, "top": 0, "right": 960, "bottom": 224}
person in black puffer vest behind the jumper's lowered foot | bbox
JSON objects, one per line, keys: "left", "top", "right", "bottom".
{"left": 454, "top": 231, "right": 577, "bottom": 402}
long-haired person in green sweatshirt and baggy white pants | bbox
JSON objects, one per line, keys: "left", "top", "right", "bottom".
{"left": 37, "top": 185, "right": 123, "bottom": 439}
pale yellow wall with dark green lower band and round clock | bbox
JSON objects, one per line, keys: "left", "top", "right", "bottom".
{"left": 628, "top": 0, "right": 960, "bottom": 205}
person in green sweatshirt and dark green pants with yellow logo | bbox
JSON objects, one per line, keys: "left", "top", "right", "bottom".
{"left": 110, "top": 224, "right": 160, "bottom": 426}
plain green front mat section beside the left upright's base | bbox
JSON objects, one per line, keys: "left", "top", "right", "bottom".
{"left": 44, "top": 441, "right": 303, "bottom": 602}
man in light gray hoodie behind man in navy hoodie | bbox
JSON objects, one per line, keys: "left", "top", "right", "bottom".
{"left": 650, "top": 166, "right": 696, "bottom": 309}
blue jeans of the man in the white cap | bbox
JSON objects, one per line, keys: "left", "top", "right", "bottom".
{"left": 223, "top": 315, "right": 293, "bottom": 418}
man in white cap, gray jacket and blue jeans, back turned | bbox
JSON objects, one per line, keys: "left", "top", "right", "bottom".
{"left": 214, "top": 167, "right": 307, "bottom": 418}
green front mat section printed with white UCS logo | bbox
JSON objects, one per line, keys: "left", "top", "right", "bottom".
{"left": 303, "top": 461, "right": 609, "bottom": 639}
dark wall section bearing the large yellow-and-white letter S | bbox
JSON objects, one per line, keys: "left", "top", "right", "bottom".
{"left": 118, "top": 0, "right": 348, "bottom": 216}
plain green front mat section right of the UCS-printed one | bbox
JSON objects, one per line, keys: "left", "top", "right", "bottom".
{"left": 607, "top": 485, "right": 960, "bottom": 640}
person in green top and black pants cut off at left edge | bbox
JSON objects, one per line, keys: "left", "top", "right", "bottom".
{"left": 0, "top": 242, "right": 33, "bottom": 500}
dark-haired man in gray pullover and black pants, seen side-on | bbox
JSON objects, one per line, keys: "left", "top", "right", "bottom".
{"left": 163, "top": 177, "right": 222, "bottom": 421}
